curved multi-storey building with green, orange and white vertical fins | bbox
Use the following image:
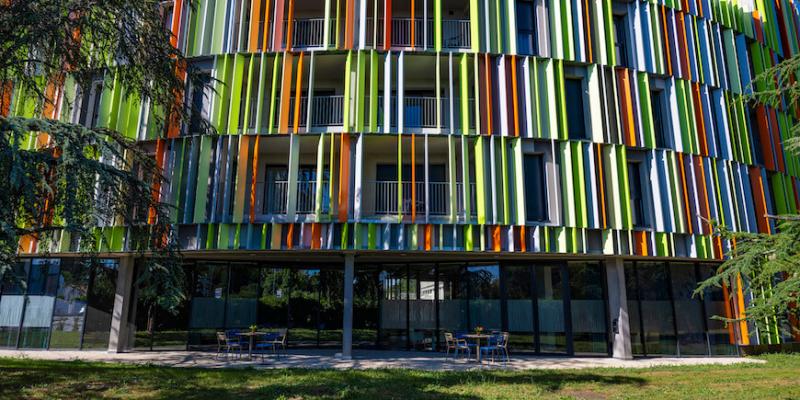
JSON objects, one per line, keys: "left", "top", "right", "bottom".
{"left": 0, "top": 0, "right": 800, "bottom": 357}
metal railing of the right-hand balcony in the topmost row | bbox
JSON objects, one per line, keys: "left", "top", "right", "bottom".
{"left": 367, "top": 18, "right": 472, "bottom": 49}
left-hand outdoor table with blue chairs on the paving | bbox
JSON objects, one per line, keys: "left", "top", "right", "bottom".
{"left": 216, "top": 329, "right": 287, "bottom": 362}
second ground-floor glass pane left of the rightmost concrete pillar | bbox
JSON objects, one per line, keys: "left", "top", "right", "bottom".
{"left": 534, "top": 265, "right": 567, "bottom": 353}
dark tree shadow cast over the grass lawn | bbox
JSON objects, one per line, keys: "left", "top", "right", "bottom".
{"left": 0, "top": 360, "right": 647, "bottom": 400}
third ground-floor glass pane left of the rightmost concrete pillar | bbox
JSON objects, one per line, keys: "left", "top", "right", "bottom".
{"left": 504, "top": 265, "right": 535, "bottom": 352}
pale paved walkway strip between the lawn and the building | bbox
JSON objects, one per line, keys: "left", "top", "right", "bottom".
{"left": 0, "top": 350, "right": 763, "bottom": 371}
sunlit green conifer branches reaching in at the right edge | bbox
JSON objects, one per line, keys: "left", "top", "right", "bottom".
{"left": 695, "top": 56, "right": 800, "bottom": 337}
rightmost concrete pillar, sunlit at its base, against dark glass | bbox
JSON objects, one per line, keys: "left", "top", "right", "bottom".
{"left": 606, "top": 258, "right": 633, "bottom": 360}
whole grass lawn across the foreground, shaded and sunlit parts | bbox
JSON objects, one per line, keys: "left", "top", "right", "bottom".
{"left": 0, "top": 355, "right": 800, "bottom": 400}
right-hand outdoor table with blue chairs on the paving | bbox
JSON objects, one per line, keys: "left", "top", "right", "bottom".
{"left": 444, "top": 331, "right": 509, "bottom": 363}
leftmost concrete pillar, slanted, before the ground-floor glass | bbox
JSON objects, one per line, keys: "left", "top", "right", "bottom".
{"left": 108, "top": 257, "right": 134, "bottom": 353}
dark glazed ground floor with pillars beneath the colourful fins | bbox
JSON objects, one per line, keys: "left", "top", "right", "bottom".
{"left": 0, "top": 252, "right": 757, "bottom": 359}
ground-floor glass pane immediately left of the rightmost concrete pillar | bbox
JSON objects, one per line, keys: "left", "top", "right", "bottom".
{"left": 569, "top": 262, "right": 609, "bottom": 354}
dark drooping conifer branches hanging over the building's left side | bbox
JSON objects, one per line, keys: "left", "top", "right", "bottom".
{"left": 0, "top": 0, "right": 209, "bottom": 316}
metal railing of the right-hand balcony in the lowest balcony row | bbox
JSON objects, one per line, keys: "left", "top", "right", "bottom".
{"left": 371, "top": 181, "right": 476, "bottom": 216}
